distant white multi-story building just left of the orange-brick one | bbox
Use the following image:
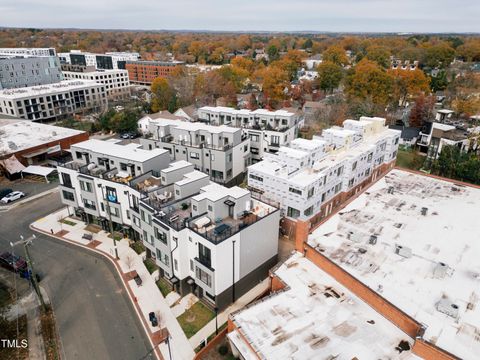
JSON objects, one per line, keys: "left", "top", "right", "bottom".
{"left": 63, "top": 70, "right": 130, "bottom": 100}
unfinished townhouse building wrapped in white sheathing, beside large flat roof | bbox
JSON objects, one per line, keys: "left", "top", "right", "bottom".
{"left": 248, "top": 117, "right": 400, "bottom": 231}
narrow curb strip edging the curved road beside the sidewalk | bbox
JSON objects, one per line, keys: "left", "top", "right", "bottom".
{"left": 30, "top": 224, "right": 164, "bottom": 360}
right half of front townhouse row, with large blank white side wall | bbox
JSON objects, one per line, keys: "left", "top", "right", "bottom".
{"left": 134, "top": 165, "right": 279, "bottom": 309}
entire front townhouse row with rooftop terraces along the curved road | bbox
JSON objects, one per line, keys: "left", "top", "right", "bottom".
{"left": 58, "top": 140, "right": 280, "bottom": 309}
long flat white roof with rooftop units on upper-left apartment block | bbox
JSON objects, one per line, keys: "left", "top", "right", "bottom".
{"left": 0, "top": 79, "right": 104, "bottom": 99}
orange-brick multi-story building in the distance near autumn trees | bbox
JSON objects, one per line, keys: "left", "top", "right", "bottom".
{"left": 125, "top": 61, "right": 184, "bottom": 85}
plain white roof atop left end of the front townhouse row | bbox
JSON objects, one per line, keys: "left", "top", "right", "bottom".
{"left": 72, "top": 139, "right": 168, "bottom": 162}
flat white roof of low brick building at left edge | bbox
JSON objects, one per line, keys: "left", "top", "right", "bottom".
{"left": 0, "top": 120, "right": 85, "bottom": 154}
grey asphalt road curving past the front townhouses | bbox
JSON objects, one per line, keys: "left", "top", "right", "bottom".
{"left": 0, "top": 193, "right": 151, "bottom": 360}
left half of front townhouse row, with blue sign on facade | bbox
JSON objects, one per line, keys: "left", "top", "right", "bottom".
{"left": 57, "top": 139, "right": 170, "bottom": 240}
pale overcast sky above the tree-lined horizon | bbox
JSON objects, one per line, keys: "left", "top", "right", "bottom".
{"left": 0, "top": 0, "right": 480, "bottom": 32}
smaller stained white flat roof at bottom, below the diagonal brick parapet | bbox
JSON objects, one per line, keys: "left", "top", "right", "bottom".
{"left": 229, "top": 253, "right": 418, "bottom": 360}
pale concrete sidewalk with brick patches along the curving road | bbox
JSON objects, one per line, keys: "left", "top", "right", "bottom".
{"left": 31, "top": 209, "right": 195, "bottom": 360}
